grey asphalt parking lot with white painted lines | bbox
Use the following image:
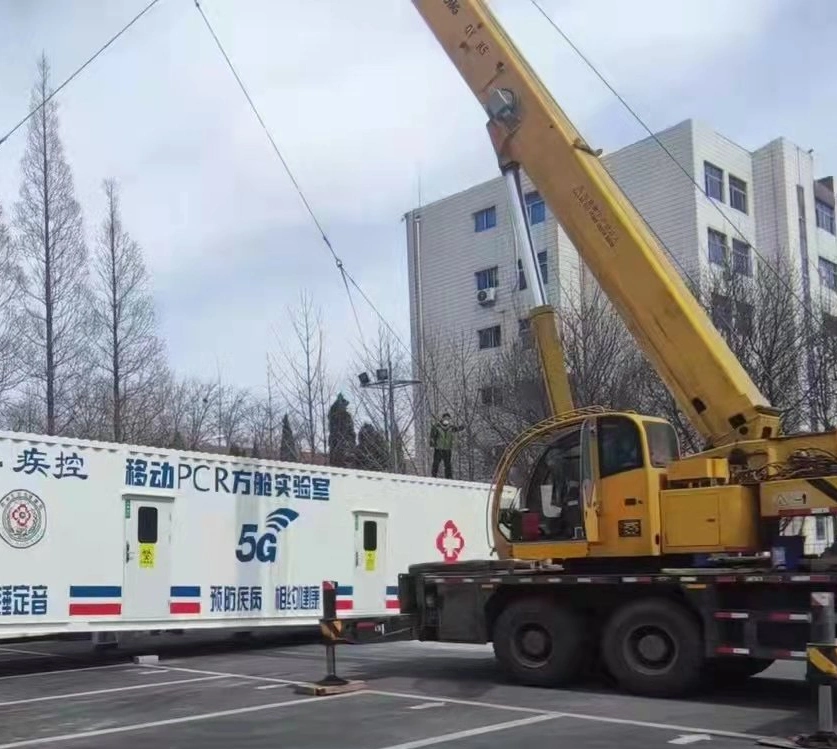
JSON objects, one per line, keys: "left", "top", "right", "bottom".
{"left": 0, "top": 638, "right": 815, "bottom": 749}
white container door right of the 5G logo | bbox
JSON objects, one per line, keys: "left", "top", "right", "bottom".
{"left": 352, "top": 512, "right": 387, "bottom": 614}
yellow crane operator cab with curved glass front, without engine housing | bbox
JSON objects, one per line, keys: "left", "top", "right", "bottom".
{"left": 497, "top": 412, "right": 679, "bottom": 559}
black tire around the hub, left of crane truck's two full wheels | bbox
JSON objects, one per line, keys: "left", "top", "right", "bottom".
{"left": 492, "top": 597, "right": 590, "bottom": 687}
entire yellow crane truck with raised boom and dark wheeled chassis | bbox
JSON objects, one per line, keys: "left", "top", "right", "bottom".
{"left": 322, "top": 0, "right": 837, "bottom": 695}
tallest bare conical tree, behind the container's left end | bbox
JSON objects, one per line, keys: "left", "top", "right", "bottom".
{"left": 15, "top": 56, "right": 91, "bottom": 434}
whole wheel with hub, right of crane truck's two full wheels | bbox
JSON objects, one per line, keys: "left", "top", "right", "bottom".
{"left": 602, "top": 599, "right": 704, "bottom": 697}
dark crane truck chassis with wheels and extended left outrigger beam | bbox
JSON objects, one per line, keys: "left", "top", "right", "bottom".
{"left": 322, "top": 561, "right": 837, "bottom": 696}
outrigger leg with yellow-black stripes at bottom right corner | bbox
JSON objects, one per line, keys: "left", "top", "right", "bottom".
{"left": 758, "top": 593, "right": 837, "bottom": 749}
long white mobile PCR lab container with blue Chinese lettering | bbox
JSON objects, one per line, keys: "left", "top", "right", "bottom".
{"left": 0, "top": 432, "right": 500, "bottom": 639}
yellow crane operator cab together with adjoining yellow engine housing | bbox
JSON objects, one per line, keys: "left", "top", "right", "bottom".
{"left": 495, "top": 412, "right": 758, "bottom": 560}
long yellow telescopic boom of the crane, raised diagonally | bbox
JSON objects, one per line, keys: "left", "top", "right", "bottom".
{"left": 413, "top": 0, "right": 779, "bottom": 446}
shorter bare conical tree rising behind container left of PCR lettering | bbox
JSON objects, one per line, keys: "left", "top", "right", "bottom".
{"left": 93, "top": 179, "right": 164, "bottom": 442}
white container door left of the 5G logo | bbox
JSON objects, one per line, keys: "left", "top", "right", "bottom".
{"left": 122, "top": 497, "right": 172, "bottom": 619}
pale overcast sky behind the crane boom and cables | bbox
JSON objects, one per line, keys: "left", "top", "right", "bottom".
{"left": 0, "top": 0, "right": 837, "bottom": 400}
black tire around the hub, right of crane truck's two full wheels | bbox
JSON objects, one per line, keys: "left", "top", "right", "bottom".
{"left": 601, "top": 598, "right": 706, "bottom": 697}
